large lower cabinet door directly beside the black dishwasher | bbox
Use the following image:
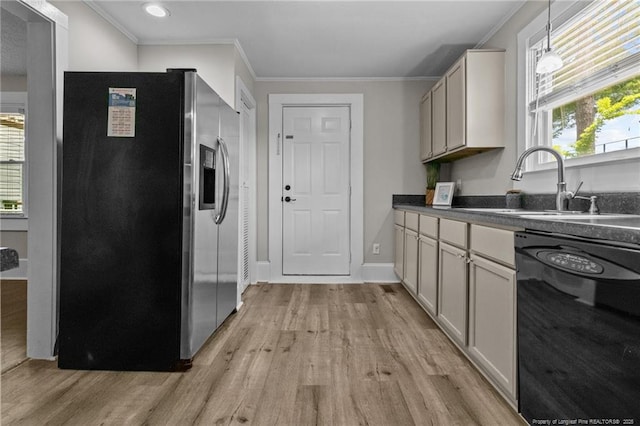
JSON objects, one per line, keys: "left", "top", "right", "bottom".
{"left": 469, "top": 255, "right": 517, "bottom": 401}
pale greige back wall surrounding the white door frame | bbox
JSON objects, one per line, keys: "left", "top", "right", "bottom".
{"left": 254, "top": 80, "right": 434, "bottom": 263}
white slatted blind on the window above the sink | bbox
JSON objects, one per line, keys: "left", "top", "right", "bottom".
{"left": 529, "top": 0, "right": 640, "bottom": 111}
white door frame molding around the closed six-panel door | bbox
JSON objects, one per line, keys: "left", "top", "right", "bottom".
{"left": 268, "top": 93, "right": 364, "bottom": 283}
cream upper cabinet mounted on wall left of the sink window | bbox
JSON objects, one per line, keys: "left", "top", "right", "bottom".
{"left": 423, "top": 50, "right": 505, "bottom": 161}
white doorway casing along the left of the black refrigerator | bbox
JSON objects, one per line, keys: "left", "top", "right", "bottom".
{"left": 11, "top": 0, "right": 68, "bottom": 359}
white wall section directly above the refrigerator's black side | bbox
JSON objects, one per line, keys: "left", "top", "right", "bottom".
{"left": 50, "top": 1, "right": 138, "bottom": 71}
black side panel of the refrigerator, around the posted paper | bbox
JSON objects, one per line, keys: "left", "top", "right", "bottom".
{"left": 58, "top": 73, "right": 184, "bottom": 371}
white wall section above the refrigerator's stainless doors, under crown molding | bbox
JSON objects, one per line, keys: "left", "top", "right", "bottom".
{"left": 138, "top": 44, "right": 238, "bottom": 105}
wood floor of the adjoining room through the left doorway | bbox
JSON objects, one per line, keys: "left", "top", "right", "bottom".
{"left": 0, "top": 280, "right": 27, "bottom": 373}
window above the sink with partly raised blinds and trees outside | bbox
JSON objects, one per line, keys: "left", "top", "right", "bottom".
{"left": 525, "top": 0, "right": 640, "bottom": 169}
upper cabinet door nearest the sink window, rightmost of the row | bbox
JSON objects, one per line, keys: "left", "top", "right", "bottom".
{"left": 447, "top": 56, "right": 467, "bottom": 151}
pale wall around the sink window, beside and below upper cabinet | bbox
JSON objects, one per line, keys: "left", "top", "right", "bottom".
{"left": 451, "top": 1, "right": 640, "bottom": 195}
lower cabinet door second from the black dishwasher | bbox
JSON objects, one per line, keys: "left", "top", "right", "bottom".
{"left": 438, "top": 242, "right": 468, "bottom": 346}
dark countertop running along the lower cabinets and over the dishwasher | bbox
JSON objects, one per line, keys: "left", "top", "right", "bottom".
{"left": 393, "top": 191, "right": 640, "bottom": 246}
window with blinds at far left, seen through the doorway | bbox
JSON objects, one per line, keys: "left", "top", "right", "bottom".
{"left": 0, "top": 100, "right": 26, "bottom": 217}
